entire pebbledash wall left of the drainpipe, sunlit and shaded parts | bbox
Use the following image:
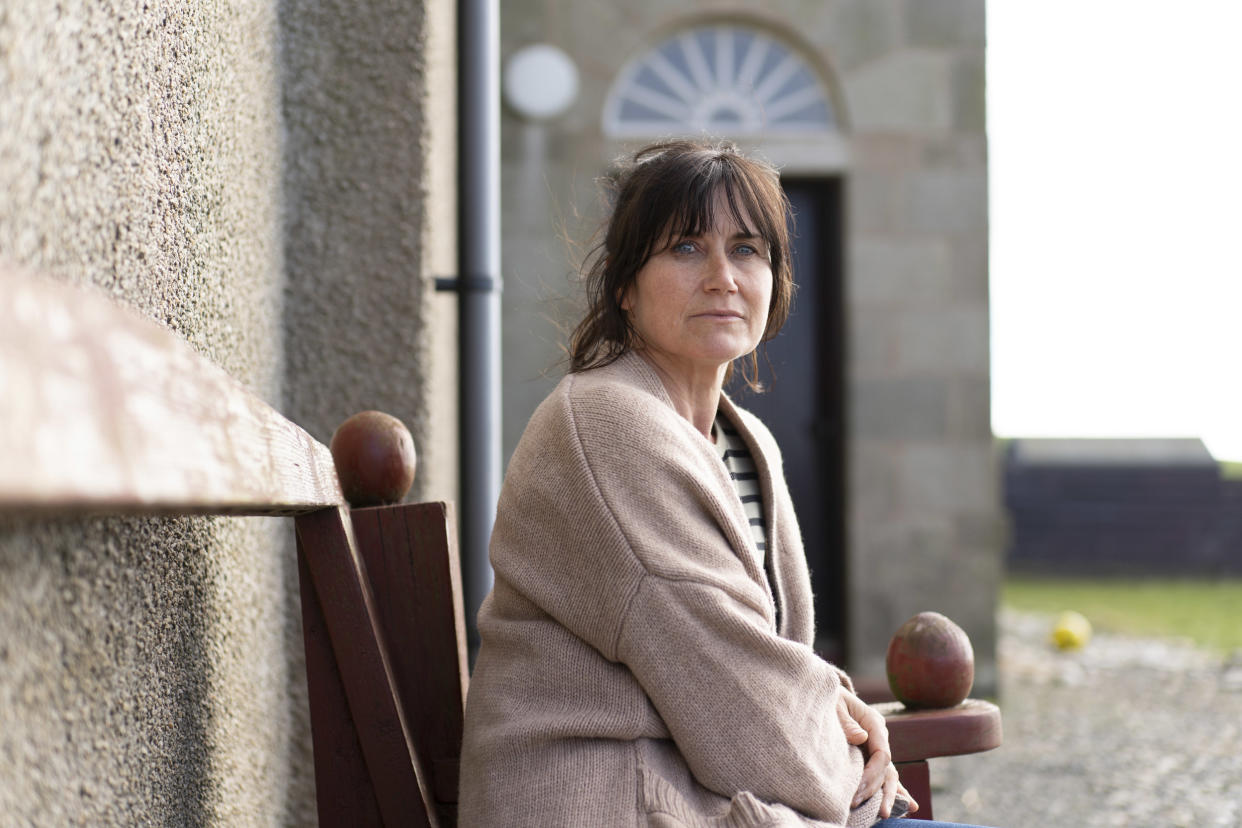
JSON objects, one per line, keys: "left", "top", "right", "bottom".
{"left": 0, "top": 0, "right": 457, "bottom": 826}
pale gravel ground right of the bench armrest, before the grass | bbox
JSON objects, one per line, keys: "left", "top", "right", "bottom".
{"left": 912, "top": 612, "right": 1242, "bottom": 828}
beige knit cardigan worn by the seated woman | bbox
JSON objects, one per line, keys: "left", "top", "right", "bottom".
{"left": 460, "top": 354, "right": 879, "bottom": 828}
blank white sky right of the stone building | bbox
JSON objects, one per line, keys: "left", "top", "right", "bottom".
{"left": 987, "top": 0, "right": 1242, "bottom": 461}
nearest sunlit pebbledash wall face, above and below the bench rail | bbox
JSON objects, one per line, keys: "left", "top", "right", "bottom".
{"left": 0, "top": 0, "right": 313, "bottom": 824}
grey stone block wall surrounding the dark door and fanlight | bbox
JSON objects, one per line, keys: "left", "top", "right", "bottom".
{"left": 502, "top": 0, "right": 1002, "bottom": 693}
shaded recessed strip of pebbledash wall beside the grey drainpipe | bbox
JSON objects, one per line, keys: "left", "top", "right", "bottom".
{"left": 281, "top": 0, "right": 456, "bottom": 500}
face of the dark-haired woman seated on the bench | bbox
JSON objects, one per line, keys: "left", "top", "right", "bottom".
{"left": 621, "top": 194, "right": 773, "bottom": 379}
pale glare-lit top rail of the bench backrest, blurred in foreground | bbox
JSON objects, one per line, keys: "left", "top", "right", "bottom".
{"left": 0, "top": 266, "right": 344, "bottom": 514}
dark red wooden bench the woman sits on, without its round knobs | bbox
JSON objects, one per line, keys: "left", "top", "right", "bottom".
{"left": 0, "top": 268, "right": 1000, "bottom": 826}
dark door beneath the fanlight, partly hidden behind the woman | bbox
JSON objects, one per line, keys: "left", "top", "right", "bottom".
{"left": 734, "top": 179, "right": 847, "bottom": 663}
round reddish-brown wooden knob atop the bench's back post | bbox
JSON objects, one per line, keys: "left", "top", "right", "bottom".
{"left": 329, "top": 411, "right": 417, "bottom": 508}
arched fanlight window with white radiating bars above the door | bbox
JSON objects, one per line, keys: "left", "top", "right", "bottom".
{"left": 604, "top": 25, "right": 836, "bottom": 138}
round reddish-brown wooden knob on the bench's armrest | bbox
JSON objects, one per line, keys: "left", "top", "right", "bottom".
{"left": 884, "top": 612, "right": 975, "bottom": 709}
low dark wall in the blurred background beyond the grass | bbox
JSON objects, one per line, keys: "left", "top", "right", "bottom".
{"left": 1004, "top": 437, "right": 1242, "bottom": 578}
